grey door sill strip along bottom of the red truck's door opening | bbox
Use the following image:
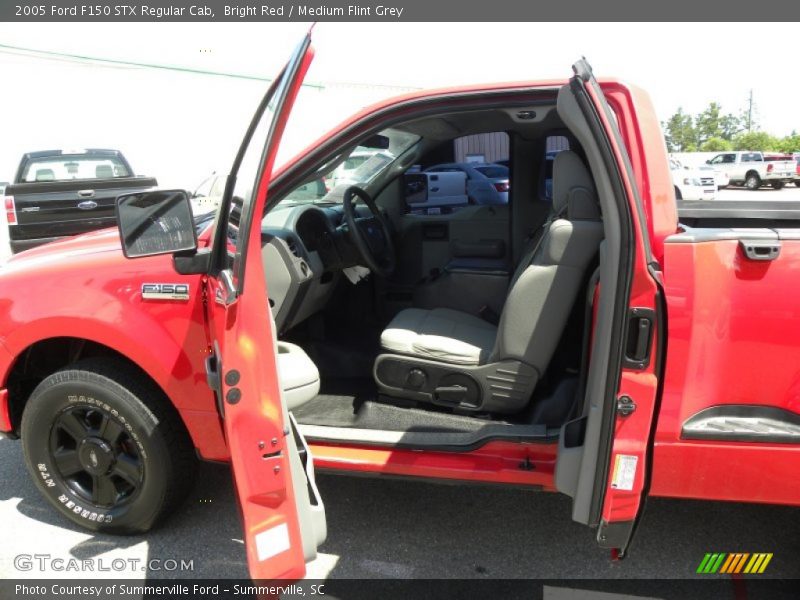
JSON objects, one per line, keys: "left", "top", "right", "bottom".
{"left": 298, "top": 424, "right": 558, "bottom": 452}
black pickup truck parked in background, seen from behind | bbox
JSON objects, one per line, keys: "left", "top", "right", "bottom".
{"left": 3, "top": 148, "right": 158, "bottom": 253}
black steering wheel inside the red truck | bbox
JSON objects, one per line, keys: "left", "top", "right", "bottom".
{"left": 342, "top": 185, "right": 396, "bottom": 277}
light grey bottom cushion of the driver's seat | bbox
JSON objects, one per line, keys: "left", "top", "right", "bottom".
{"left": 381, "top": 308, "right": 497, "bottom": 365}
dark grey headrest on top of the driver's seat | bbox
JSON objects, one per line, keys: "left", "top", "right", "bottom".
{"left": 553, "top": 150, "right": 600, "bottom": 221}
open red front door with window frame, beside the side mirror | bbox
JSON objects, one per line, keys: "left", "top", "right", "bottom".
{"left": 200, "top": 32, "right": 326, "bottom": 580}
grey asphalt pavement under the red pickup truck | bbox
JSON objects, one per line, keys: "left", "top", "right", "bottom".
{"left": 0, "top": 440, "right": 800, "bottom": 579}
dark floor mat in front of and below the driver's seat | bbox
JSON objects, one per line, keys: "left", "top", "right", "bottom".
{"left": 292, "top": 379, "right": 506, "bottom": 433}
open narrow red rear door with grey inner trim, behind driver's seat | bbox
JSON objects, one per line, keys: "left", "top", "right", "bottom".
{"left": 556, "top": 60, "right": 664, "bottom": 556}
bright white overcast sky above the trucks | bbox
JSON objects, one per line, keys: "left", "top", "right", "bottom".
{"left": 0, "top": 23, "right": 800, "bottom": 189}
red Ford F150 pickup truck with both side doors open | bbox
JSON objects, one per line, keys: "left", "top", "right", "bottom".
{"left": 0, "top": 38, "right": 800, "bottom": 579}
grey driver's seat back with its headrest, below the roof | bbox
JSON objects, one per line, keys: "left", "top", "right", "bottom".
{"left": 490, "top": 151, "right": 603, "bottom": 377}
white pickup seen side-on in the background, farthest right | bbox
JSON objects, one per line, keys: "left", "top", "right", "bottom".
{"left": 706, "top": 151, "right": 796, "bottom": 190}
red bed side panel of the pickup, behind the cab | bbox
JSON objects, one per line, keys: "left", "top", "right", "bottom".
{"left": 652, "top": 229, "right": 800, "bottom": 505}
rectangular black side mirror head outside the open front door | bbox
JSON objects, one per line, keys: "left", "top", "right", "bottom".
{"left": 117, "top": 190, "right": 197, "bottom": 258}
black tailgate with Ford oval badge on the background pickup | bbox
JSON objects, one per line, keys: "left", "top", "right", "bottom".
{"left": 5, "top": 178, "right": 156, "bottom": 240}
